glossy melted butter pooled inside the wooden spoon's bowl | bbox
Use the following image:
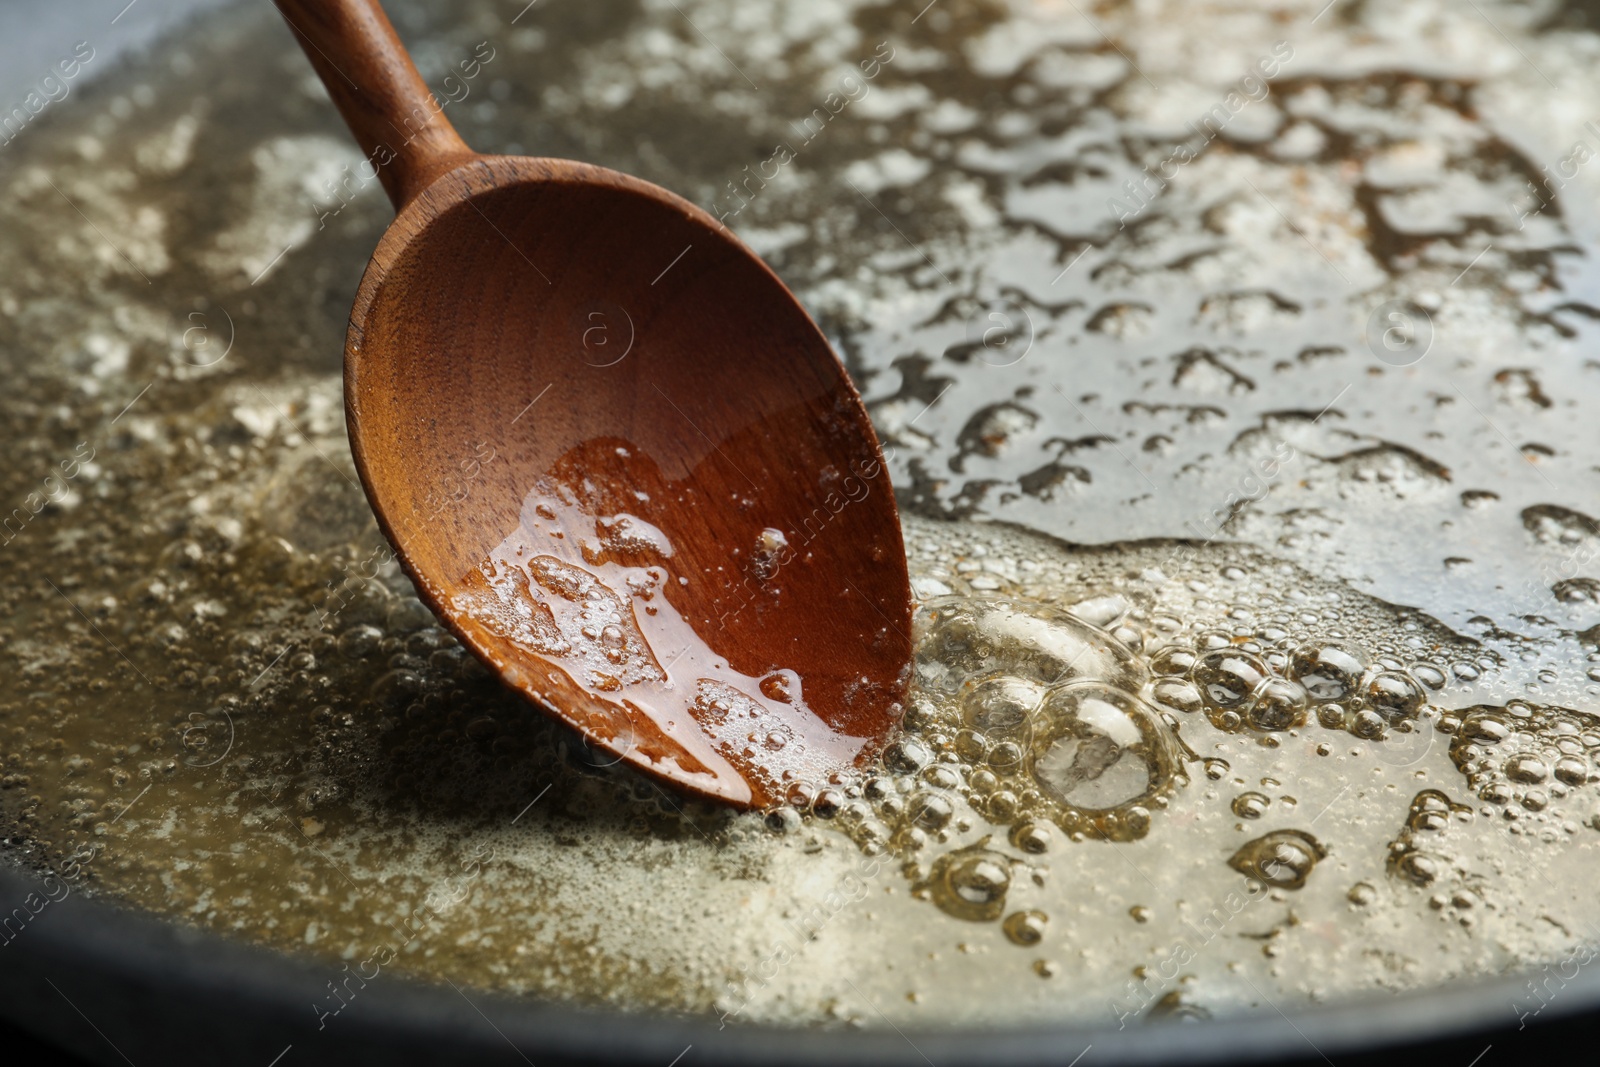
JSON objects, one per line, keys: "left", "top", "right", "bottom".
{"left": 451, "top": 460, "right": 859, "bottom": 803}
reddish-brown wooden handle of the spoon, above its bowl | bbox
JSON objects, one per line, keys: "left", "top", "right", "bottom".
{"left": 274, "top": 0, "right": 474, "bottom": 211}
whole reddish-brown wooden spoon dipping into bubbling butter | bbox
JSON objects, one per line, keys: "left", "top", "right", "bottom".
{"left": 277, "top": 0, "right": 910, "bottom": 806}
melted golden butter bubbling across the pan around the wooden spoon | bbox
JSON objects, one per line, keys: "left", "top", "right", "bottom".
{"left": 9, "top": 0, "right": 1600, "bottom": 1027}
